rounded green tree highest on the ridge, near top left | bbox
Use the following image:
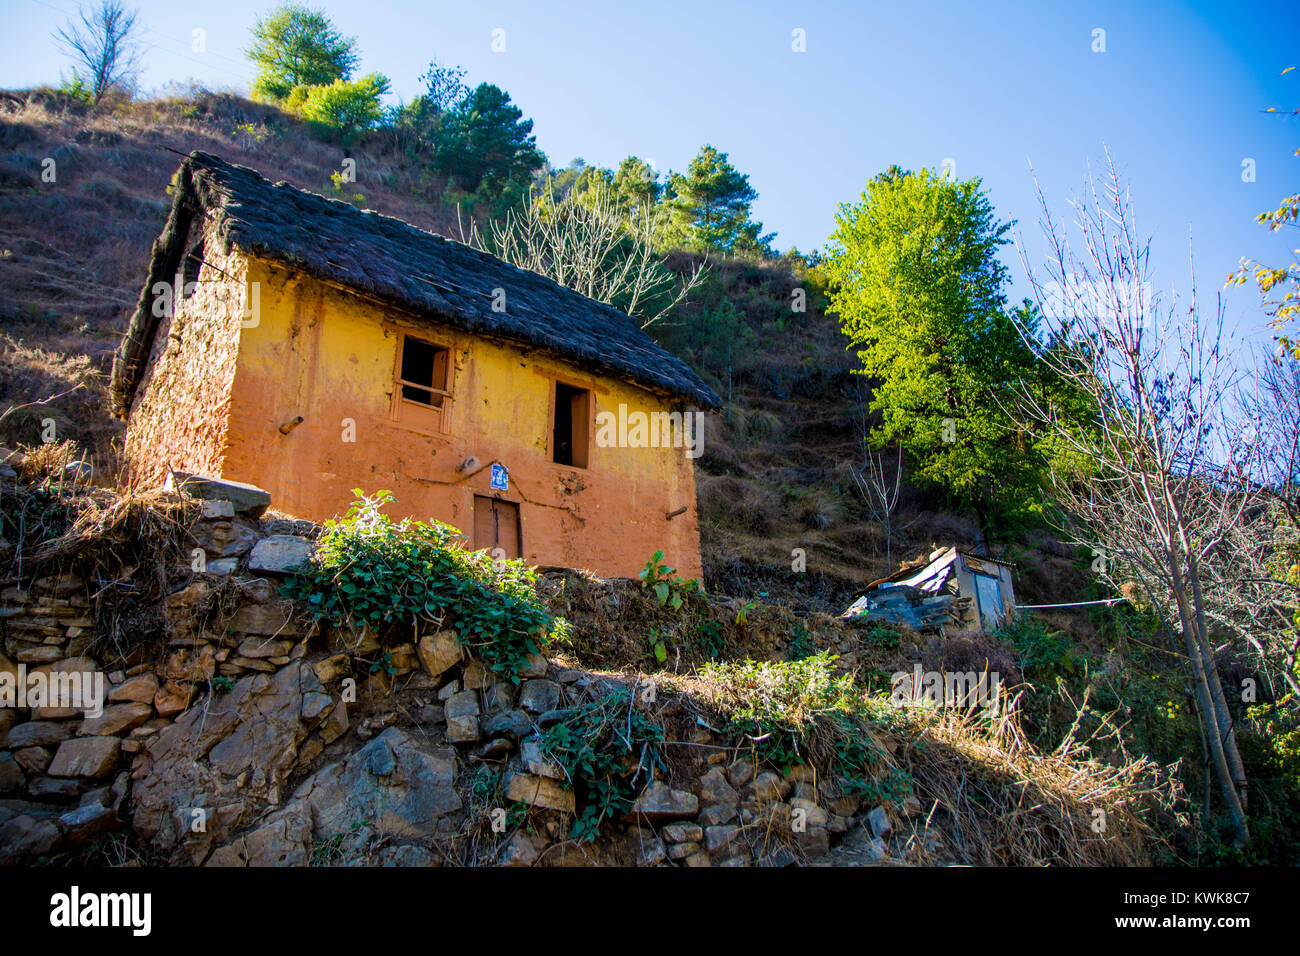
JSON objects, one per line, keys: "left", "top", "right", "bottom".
{"left": 247, "top": 4, "right": 360, "bottom": 101}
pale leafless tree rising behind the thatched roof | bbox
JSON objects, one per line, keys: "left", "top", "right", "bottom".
{"left": 460, "top": 185, "right": 705, "bottom": 328}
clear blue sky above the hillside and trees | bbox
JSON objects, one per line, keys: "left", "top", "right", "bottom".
{"left": 0, "top": 0, "right": 1300, "bottom": 343}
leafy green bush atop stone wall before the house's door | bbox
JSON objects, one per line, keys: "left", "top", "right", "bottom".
{"left": 282, "top": 489, "right": 564, "bottom": 683}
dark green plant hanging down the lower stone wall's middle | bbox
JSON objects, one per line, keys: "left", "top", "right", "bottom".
{"left": 541, "top": 687, "right": 664, "bottom": 842}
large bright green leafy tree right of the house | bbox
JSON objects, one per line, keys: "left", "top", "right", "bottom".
{"left": 822, "top": 168, "right": 1041, "bottom": 535}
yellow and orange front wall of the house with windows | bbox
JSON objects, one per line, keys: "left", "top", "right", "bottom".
{"left": 221, "top": 259, "right": 702, "bottom": 578}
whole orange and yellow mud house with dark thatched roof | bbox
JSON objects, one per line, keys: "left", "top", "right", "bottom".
{"left": 112, "top": 152, "right": 719, "bottom": 576}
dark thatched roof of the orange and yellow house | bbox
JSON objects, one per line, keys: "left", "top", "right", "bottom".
{"left": 111, "top": 151, "right": 720, "bottom": 415}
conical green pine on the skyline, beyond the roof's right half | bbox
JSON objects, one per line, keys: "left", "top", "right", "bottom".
{"left": 668, "top": 146, "right": 774, "bottom": 252}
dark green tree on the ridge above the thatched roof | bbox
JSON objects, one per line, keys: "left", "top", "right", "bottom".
{"left": 434, "top": 83, "right": 546, "bottom": 195}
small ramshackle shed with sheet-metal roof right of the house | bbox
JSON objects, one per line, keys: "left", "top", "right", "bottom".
{"left": 840, "top": 548, "right": 1015, "bottom": 631}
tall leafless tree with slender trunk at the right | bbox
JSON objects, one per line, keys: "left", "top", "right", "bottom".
{"left": 1018, "top": 153, "right": 1257, "bottom": 845}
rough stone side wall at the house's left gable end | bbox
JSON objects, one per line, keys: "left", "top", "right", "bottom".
{"left": 122, "top": 246, "right": 244, "bottom": 485}
